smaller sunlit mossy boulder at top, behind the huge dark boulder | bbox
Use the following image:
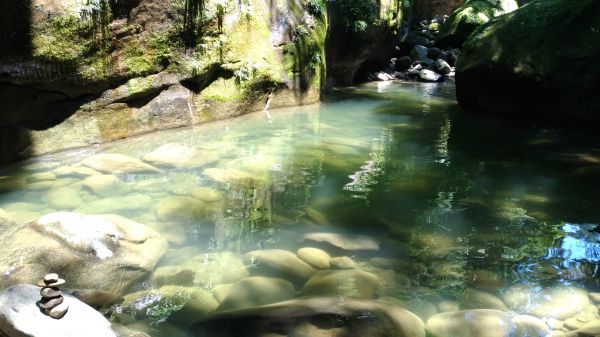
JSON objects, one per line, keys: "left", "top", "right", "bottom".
{"left": 436, "top": 0, "right": 519, "bottom": 48}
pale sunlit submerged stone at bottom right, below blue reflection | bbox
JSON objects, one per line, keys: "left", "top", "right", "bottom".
{"left": 504, "top": 286, "right": 590, "bottom": 320}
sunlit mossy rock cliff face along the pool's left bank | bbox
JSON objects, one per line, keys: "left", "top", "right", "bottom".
{"left": 0, "top": 0, "right": 328, "bottom": 161}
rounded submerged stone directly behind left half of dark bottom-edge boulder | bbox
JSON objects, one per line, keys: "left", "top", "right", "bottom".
{"left": 218, "top": 276, "right": 296, "bottom": 311}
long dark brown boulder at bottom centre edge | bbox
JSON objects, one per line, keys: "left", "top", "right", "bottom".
{"left": 191, "top": 297, "right": 425, "bottom": 337}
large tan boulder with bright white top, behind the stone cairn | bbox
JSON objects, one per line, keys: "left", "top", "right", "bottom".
{"left": 0, "top": 212, "right": 167, "bottom": 294}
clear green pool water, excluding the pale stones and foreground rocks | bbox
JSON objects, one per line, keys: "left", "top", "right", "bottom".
{"left": 0, "top": 84, "right": 600, "bottom": 335}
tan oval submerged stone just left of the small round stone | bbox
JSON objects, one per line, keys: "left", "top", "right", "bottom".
{"left": 244, "top": 249, "right": 315, "bottom": 285}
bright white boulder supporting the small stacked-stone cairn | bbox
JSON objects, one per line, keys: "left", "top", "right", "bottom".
{"left": 0, "top": 284, "right": 117, "bottom": 337}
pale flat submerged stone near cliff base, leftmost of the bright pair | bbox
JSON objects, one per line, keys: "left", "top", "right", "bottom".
{"left": 81, "top": 153, "right": 162, "bottom": 174}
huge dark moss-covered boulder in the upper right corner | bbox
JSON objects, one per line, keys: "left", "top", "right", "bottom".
{"left": 456, "top": 0, "right": 600, "bottom": 120}
